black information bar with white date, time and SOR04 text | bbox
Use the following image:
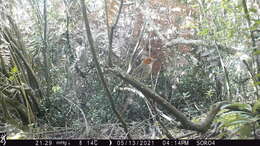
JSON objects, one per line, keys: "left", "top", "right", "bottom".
{"left": 0, "top": 139, "right": 260, "bottom": 146}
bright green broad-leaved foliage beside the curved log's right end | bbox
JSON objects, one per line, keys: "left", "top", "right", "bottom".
{"left": 216, "top": 101, "right": 260, "bottom": 139}
